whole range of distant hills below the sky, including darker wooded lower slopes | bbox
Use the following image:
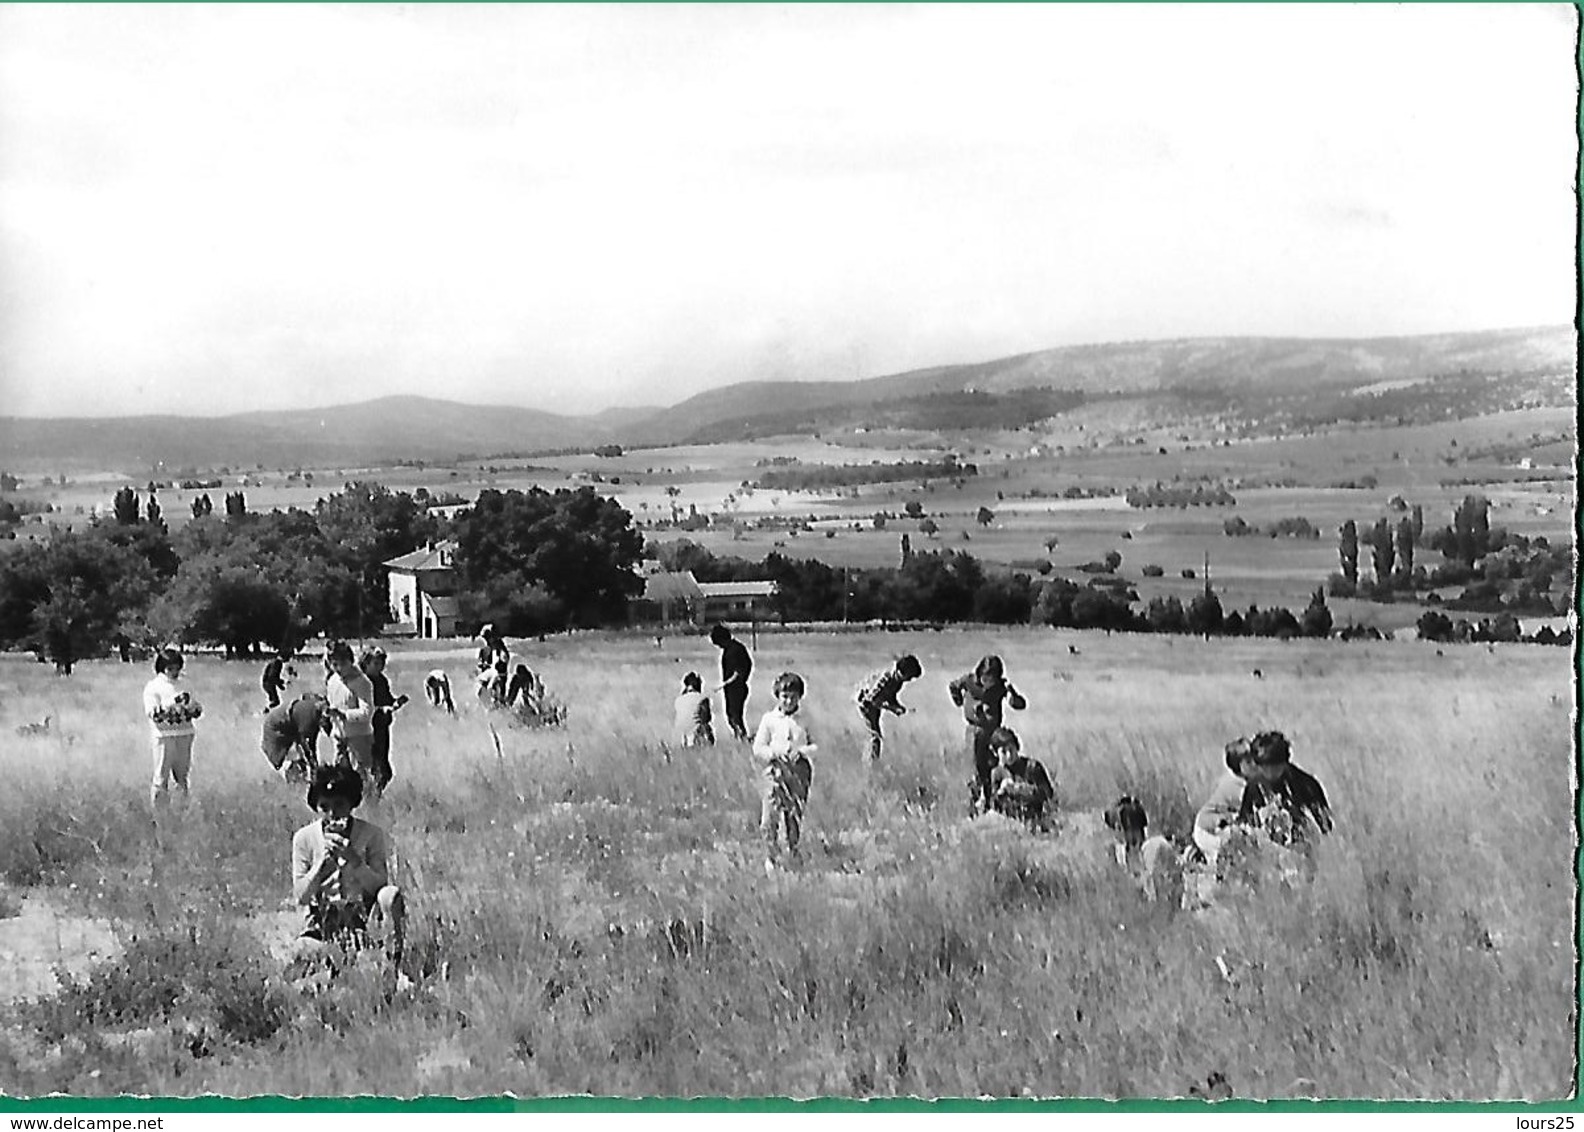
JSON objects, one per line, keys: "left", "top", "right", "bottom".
{"left": 0, "top": 326, "right": 1576, "bottom": 473}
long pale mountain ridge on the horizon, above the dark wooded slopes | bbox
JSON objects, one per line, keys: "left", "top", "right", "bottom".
{"left": 0, "top": 326, "right": 1576, "bottom": 469}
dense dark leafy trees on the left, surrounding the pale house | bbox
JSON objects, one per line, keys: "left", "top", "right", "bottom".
{"left": 0, "top": 483, "right": 642, "bottom": 665}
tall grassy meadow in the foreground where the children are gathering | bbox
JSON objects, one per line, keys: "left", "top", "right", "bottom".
{"left": 0, "top": 630, "right": 1578, "bottom": 1100}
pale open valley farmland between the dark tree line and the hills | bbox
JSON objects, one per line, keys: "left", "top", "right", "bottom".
{"left": 9, "top": 408, "right": 1576, "bottom": 630}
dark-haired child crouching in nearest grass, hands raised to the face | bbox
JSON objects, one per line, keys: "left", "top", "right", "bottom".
{"left": 288, "top": 763, "right": 407, "bottom": 977}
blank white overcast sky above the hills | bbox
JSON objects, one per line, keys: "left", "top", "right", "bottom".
{"left": 0, "top": 3, "right": 1576, "bottom": 416}
